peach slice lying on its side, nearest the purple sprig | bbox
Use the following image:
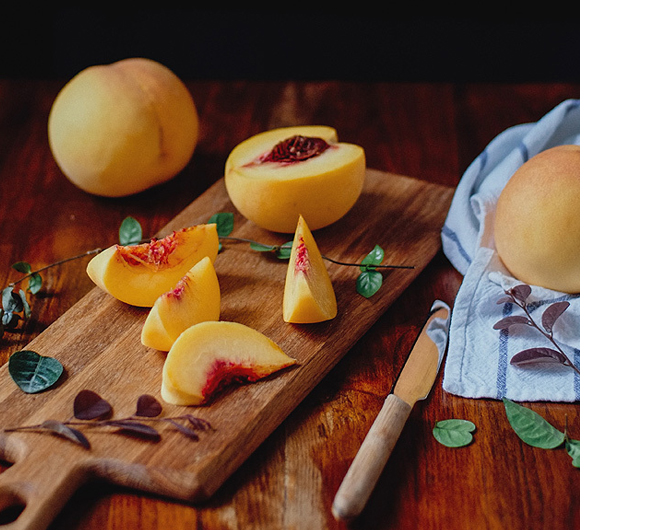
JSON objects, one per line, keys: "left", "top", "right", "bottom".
{"left": 161, "top": 321, "right": 296, "bottom": 405}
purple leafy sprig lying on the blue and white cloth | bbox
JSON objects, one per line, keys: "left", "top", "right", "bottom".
{"left": 493, "top": 284, "right": 580, "bottom": 374}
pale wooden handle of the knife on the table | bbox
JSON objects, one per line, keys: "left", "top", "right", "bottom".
{"left": 332, "top": 394, "right": 412, "bottom": 521}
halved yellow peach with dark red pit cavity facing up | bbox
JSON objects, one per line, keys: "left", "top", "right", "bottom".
{"left": 224, "top": 125, "right": 365, "bottom": 233}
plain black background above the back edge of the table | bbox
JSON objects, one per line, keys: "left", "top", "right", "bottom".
{"left": 0, "top": 8, "right": 580, "bottom": 82}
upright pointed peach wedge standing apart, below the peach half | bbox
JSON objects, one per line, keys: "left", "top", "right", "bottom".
{"left": 282, "top": 216, "right": 338, "bottom": 324}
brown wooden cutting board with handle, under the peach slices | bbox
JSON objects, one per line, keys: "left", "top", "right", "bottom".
{"left": 0, "top": 169, "right": 453, "bottom": 529}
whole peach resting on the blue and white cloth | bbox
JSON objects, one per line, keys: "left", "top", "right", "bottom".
{"left": 494, "top": 145, "right": 580, "bottom": 293}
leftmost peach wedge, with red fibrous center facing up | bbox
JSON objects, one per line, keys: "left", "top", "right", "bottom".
{"left": 86, "top": 223, "right": 219, "bottom": 307}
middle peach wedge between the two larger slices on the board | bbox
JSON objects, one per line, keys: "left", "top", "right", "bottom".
{"left": 141, "top": 256, "right": 221, "bottom": 351}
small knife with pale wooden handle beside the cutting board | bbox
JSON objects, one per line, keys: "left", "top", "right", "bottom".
{"left": 332, "top": 301, "right": 450, "bottom": 521}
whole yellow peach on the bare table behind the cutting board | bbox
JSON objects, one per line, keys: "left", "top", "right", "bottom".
{"left": 48, "top": 57, "right": 199, "bottom": 197}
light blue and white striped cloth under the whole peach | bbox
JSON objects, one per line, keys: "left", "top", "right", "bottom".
{"left": 442, "top": 100, "right": 580, "bottom": 402}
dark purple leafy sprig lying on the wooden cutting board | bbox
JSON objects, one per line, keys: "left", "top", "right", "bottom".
{"left": 3, "top": 390, "right": 213, "bottom": 449}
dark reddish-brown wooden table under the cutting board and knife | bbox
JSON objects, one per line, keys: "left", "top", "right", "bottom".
{"left": 0, "top": 79, "right": 580, "bottom": 530}
